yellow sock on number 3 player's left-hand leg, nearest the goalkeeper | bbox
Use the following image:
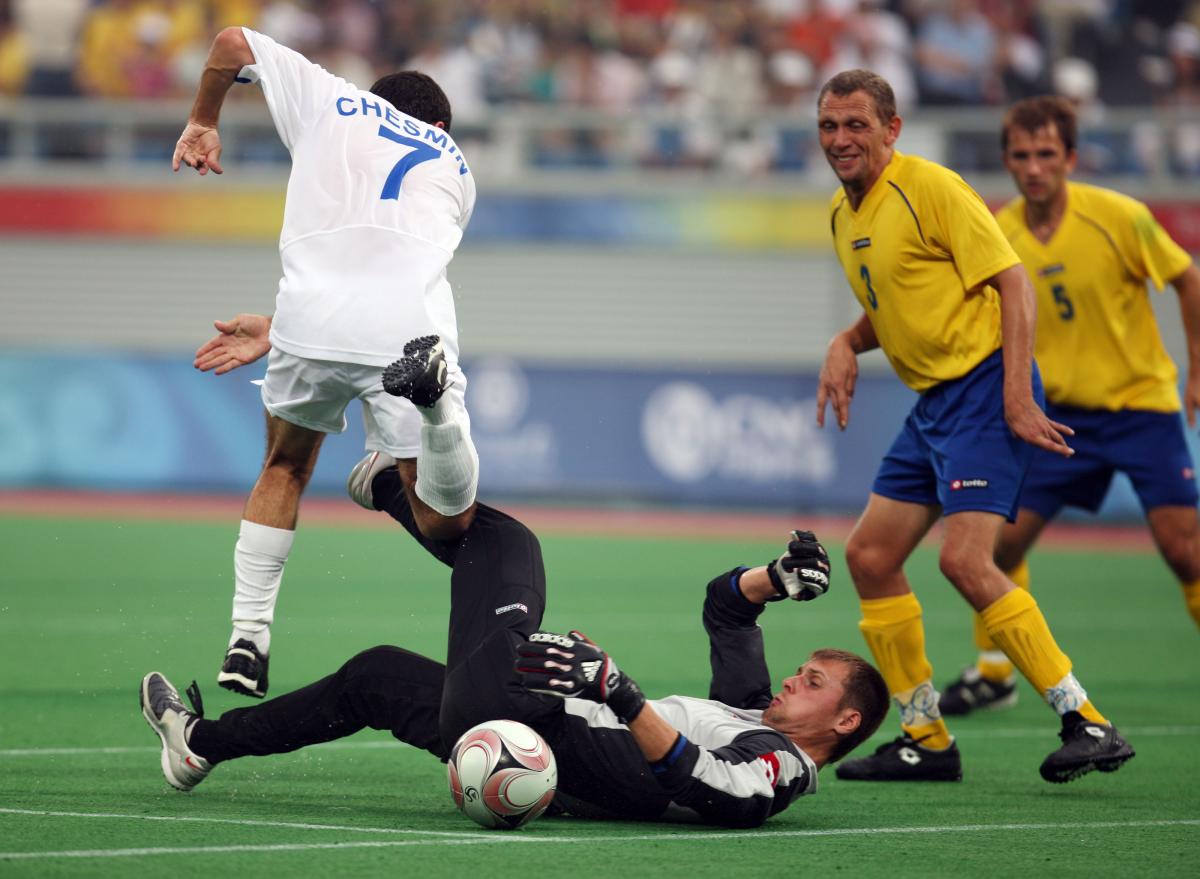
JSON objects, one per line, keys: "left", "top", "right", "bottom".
{"left": 858, "top": 592, "right": 953, "bottom": 749}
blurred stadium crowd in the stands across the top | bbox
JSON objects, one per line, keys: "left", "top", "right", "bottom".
{"left": 0, "top": 0, "right": 1200, "bottom": 172}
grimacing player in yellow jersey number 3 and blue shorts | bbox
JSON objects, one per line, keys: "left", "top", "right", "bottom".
{"left": 817, "top": 71, "right": 1133, "bottom": 782}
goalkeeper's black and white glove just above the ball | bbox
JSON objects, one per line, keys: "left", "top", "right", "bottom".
{"left": 515, "top": 630, "right": 646, "bottom": 723}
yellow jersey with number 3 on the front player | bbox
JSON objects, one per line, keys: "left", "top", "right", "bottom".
{"left": 829, "top": 153, "right": 1020, "bottom": 391}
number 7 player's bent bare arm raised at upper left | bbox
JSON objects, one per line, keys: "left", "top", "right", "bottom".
{"left": 170, "top": 28, "right": 254, "bottom": 177}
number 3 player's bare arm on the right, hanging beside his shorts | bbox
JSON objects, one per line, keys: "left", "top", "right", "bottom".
{"left": 986, "top": 263, "right": 1075, "bottom": 458}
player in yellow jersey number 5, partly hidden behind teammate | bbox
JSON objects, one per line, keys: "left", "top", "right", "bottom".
{"left": 941, "top": 97, "right": 1200, "bottom": 714}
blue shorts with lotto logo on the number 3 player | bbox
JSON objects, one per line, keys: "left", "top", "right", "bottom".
{"left": 871, "top": 351, "right": 1045, "bottom": 521}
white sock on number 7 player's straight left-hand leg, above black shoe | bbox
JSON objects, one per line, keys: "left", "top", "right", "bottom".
{"left": 229, "top": 519, "right": 295, "bottom": 656}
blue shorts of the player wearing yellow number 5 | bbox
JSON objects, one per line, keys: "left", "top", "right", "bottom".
{"left": 1021, "top": 403, "right": 1200, "bottom": 520}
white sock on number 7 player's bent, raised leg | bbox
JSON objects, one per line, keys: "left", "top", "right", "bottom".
{"left": 415, "top": 396, "right": 479, "bottom": 516}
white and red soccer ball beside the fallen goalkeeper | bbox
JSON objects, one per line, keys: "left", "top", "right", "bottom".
{"left": 446, "top": 720, "right": 558, "bottom": 830}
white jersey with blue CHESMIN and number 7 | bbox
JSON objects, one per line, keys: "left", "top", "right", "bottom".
{"left": 238, "top": 28, "right": 475, "bottom": 366}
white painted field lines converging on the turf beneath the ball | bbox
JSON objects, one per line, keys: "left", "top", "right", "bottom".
{"left": 0, "top": 809, "right": 1200, "bottom": 861}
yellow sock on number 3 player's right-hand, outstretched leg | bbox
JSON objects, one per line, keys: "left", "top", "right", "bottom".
{"left": 980, "top": 590, "right": 1108, "bottom": 723}
